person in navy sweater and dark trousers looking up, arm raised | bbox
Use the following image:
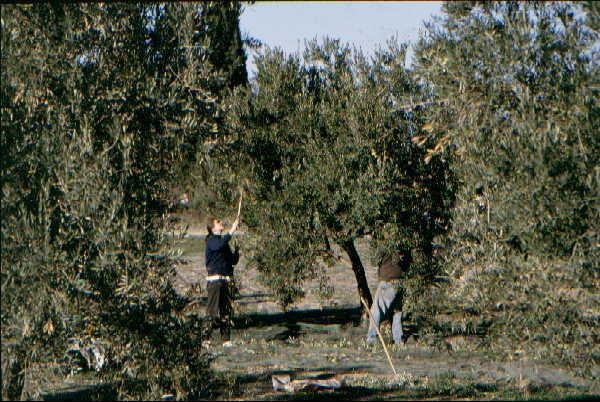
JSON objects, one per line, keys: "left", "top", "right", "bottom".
{"left": 204, "top": 217, "right": 239, "bottom": 346}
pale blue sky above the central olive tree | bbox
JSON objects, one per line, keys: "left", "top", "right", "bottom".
{"left": 240, "top": 1, "right": 442, "bottom": 76}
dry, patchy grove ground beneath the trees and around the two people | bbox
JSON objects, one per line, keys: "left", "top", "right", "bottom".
{"left": 171, "top": 230, "right": 600, "bottom": 400}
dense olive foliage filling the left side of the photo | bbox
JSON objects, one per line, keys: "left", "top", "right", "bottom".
{"left": 1, "top": 3, "right": 244, "bottom": 399}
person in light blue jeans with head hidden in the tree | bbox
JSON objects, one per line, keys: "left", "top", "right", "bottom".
{"left": 367, "top": 248, "right": 412, "bottom": 345}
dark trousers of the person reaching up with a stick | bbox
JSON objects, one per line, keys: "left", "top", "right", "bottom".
{"left": 205, "top": 280, "right": 232, "bottom": 341}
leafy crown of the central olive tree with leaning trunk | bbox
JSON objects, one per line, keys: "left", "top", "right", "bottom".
{"left": 228, "top": 39, "right": 452, "bottom": 305}
